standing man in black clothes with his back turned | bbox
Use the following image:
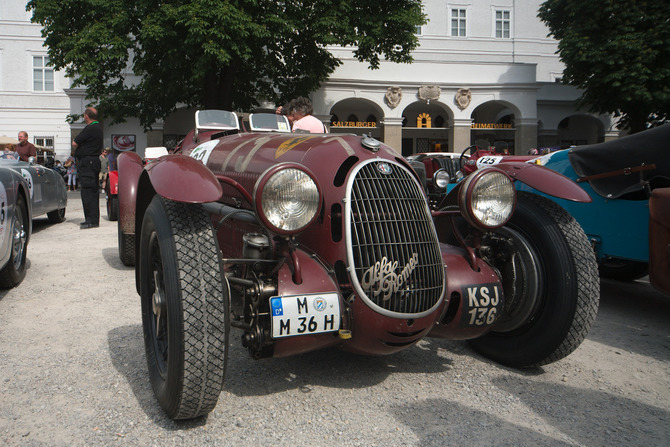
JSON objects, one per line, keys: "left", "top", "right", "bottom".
{"left": 72, "top": 107, "right": 103, "bottom": 230}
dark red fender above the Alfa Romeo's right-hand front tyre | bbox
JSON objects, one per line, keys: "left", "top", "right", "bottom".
{"left": 495, "top": 161, "right": 591, "bottom": 203}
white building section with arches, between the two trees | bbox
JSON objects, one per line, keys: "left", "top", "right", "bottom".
{"left": 313, "top": 0, "right": 618, "bottom": 155}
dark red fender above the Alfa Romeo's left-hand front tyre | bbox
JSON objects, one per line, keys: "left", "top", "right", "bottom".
{"left": 146, "top": 154, "right": 223, "bottom": 203}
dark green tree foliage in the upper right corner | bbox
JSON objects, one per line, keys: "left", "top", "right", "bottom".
{"left": 538, "top": 0, "right": 670, "bottom": 132}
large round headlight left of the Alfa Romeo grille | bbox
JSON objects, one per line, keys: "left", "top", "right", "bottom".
{"left": 256, "top": 167, "right": 321, "bottom": 234}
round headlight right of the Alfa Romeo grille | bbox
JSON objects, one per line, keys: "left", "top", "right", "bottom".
{"left": 459, "top": 169, "right": 516, "bottom": 230}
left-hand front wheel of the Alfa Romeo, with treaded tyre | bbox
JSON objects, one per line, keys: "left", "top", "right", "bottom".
{"left": 139, "top": 196, "right": 230, "bottom": 419}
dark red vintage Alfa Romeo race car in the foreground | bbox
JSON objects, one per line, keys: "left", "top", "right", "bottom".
{"left": 118, "top": 110, "right": 599, "bottom": 419}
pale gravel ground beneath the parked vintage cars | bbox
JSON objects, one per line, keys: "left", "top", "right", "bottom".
{"left": 0, "top": 193, "right": 670, "bottom": 446}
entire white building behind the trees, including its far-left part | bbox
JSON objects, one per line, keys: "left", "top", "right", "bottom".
{"left": 0, "top": 0, "right": 618, "bottom": 157}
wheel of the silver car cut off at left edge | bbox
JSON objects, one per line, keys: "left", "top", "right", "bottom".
{"left": 0, "top": 195, "right": 30, "bottom": 288}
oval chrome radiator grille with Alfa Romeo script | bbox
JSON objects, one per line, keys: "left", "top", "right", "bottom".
{"left": 346, "top": 160, "right": 445, "bottom": 317}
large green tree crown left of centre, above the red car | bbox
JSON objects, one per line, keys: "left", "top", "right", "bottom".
{"left": 27, "top": 0, "right": 426, "bottom": 127}
